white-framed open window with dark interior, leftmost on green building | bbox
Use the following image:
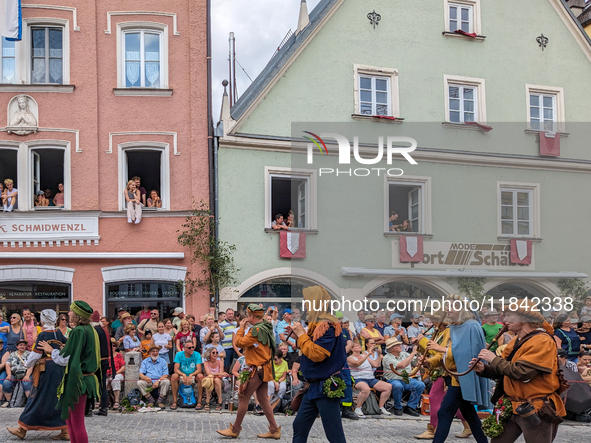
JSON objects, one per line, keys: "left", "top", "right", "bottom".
{"left": 265, "top": 167, "right": 316, "bottom": 229}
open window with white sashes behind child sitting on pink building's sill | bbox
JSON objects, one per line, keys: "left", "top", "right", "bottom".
{"left": 119, "top": 147, "right": 170, "bottom": 210}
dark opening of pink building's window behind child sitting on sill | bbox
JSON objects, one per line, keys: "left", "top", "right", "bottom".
{"left": 123, "top": 149, "right": 163, "bottom": 210}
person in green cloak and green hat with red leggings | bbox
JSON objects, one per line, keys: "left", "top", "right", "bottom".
{"left": 38, "top": 301, "right": 101, "bottom": 443}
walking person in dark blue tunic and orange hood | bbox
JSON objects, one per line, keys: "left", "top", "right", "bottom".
{"left": 288, "top": 286, "right": 347, "bottom": 443}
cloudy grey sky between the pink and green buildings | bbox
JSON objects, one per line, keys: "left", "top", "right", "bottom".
{"left": 211, "top": 0, "right": 320, "bottom": 122}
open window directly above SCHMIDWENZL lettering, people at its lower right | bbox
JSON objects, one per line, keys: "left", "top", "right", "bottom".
{"left": 30, "top": 148, "right": 64, "bottom": 210}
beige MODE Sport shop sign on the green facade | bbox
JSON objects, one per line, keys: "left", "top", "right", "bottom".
{"left": 392, "top": 240, "right": 535, "bottom": 270}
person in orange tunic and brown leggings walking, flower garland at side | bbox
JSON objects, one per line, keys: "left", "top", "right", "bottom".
{"left": 217, "top": 303, "right": 281, "bottom": 439}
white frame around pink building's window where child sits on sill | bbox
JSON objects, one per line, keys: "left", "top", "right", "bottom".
{"left": 117, "top": 141, "right": 171, "bottom": 211}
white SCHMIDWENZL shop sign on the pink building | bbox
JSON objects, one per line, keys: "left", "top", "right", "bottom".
{"left": 0, "top": 214, "right": 100, "bottom": 242}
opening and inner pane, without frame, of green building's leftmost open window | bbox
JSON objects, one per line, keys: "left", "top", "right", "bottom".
{"left": 271, "top": 175, "right": 310, "bottom": 229}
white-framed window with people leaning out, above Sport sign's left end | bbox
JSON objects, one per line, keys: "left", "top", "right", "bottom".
{"left": 384, "top": 177, "right": 431, "bottom": 234}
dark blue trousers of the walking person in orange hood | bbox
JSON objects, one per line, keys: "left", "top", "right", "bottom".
{"left": 292, "top": 394, "right": 346, "bottom": 443}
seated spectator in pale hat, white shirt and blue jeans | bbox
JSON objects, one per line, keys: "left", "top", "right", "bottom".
{"left": 383, "top": 337, "right": 425, "bottom": 417}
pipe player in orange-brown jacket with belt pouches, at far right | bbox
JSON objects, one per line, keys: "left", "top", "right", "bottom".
{"left": 473, "top": 299, "right": 567, "bottom": 443}
